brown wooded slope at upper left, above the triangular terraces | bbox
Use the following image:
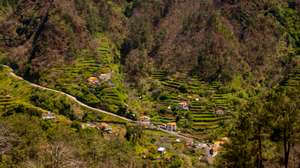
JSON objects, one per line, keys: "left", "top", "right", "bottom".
{"left": 0, "top": 0, "right": 124, "bottom": 79}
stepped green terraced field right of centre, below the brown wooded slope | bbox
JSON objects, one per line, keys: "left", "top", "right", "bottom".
{"left": 151, "top": 71, "right": 233, "bottom": 131}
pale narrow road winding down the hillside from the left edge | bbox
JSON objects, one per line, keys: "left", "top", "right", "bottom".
{"left": 3, "top": 65, "right": 199, "bottom": 141}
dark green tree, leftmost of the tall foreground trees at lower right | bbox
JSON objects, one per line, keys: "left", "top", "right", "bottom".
{"left": 217, "top": 96, "right": 270, "bottom": 168}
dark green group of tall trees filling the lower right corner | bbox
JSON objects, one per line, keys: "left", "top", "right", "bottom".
{"left": 219, "top": 84, "right": 300, "bottom": 167}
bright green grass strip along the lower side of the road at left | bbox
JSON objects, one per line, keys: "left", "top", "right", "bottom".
{"left": 0, "top": 66, "right": 126, "bottom": 123}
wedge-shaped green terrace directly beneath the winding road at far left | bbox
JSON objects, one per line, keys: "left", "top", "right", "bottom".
{"left": 0, "top": 65, "right": 127, "bottom": 123}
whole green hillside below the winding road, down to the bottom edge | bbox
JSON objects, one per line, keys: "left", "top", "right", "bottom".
{"left": 0, "top": 65, "right": 201, "bottom": 168}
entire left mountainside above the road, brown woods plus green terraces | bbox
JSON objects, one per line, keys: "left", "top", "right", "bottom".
{"left": 0, "top": 0, "right": 130, "bottom": 116}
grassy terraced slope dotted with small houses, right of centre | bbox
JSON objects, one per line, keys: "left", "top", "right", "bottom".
{"left": 150, "top": 71, "right": 238, "bottom": 132}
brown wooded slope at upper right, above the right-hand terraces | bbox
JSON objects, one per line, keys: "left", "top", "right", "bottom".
{"left": 123, "top": 0, "right": 299, "bottom": 81}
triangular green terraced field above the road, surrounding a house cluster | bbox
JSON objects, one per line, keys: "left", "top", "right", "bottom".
{"left": 39, "top": 36, "right": 126, "bottom": 112}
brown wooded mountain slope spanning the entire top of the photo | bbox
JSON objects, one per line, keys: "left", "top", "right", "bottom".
{"left": 0, "top": 0, "right": 299, "bottom": 83}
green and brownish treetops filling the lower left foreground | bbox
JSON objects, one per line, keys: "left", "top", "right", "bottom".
{"left": 0, "top": 114, "right": 141, "bottom": 167}
